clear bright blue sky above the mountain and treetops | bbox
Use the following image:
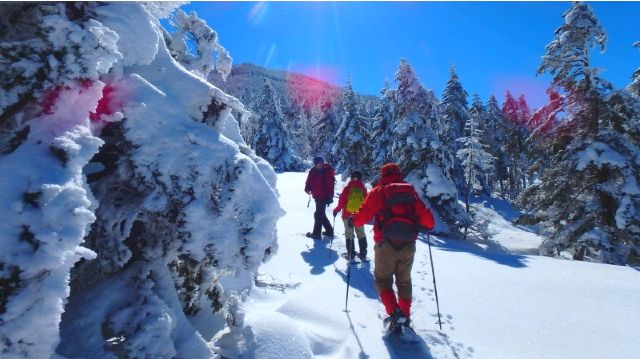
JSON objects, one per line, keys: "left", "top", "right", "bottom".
{"left": 176, "top": 2, "right": 640, "bottom": 107}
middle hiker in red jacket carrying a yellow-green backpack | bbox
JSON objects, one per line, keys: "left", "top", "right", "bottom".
{"left": 333, "top": 171, "right": 367, "bottom": 262}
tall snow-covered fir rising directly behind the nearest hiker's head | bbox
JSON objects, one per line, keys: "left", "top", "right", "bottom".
{"left": 391, "top": 60, "right": 469, "bottom": 235}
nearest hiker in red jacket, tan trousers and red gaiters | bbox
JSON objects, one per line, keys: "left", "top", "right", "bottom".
{"left": 352, "top": 163, "right": 434, "bottom": 325}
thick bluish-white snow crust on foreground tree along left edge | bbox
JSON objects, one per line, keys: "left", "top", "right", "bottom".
{"left": 0, "top": 81, "right": 102, "bottom": 357}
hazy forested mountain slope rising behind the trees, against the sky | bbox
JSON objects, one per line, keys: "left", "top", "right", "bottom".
{"left": 208, "top": 63, "right": 379, "bottom": 164}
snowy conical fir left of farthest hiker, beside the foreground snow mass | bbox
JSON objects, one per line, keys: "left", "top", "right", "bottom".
{"left": 253, "top": 79, "right": 305, "bottom": 171}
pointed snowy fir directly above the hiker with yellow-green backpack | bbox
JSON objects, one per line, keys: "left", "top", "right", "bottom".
{"left": 331, "top": 79, "right": 371, "bottom": 181}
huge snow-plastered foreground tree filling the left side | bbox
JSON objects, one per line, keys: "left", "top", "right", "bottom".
{"left": 0, "top": 3, "right": 282, "bottom": 358}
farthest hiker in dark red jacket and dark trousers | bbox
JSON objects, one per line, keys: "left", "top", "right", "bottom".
{"left": 304, "top": 156, "right": 336, "bottom": 239}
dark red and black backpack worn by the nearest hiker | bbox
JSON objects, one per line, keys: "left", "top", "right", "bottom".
{"left": 376, "top": 183, "right": 419, "bottom": 242}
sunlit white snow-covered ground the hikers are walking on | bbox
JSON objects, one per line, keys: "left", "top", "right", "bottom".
{"left": 245, "top": 173, "right": 640, "bottom": 359}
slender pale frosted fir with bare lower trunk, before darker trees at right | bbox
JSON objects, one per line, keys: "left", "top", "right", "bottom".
{"left": 456, "top": 94, "right": 494, "bottom": 213}
